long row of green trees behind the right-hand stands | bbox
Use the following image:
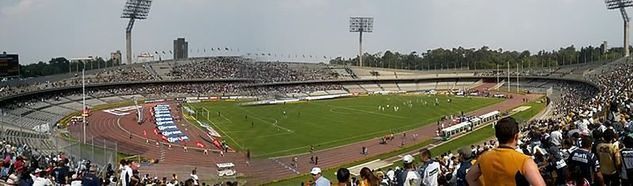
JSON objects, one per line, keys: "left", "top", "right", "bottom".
{"left": 330, "top": 45, "right": 623, "bottom": 70}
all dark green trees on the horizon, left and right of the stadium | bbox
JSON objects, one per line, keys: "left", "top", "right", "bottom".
{"left": 13, "top": 45, "right": 633, "bottom": 78}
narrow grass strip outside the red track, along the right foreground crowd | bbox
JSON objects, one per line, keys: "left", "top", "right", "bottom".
{"left": 265, "top": 101, "right": 545, "bottom": 185}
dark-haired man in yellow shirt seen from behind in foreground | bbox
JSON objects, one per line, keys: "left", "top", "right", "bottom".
{"left": 466, "top": 117, "right": 545, "bottom": 186}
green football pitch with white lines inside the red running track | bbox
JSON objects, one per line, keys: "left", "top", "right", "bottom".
{"left": 187, "top": 95, "right": 502, "bottom": 157}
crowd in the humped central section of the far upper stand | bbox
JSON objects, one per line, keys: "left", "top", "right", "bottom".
{"left": 169, "top": 57, "right": 336, "bottom": 82}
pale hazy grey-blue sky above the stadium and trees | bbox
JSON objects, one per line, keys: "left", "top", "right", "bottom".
{"left": 0, "top": 0, "right": 623, "bottom": 64}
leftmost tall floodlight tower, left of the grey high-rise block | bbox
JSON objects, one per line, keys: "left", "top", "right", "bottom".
{"left": 121, "top": 0, "right": 152, "bottom": 64}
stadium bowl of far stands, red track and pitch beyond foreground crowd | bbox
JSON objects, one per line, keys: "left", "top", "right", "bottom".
{"left": 2, "top": 53, "right": 619, "bottom": 184}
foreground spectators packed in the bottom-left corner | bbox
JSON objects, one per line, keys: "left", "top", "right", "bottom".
{"left": 0, "top": 141, "right": 238, "bottom": 186}
